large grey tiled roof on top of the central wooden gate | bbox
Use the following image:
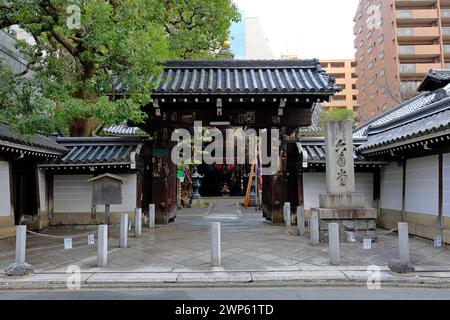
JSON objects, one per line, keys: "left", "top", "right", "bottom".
{"left": 154, "top": 60, "right": 340, "bottom": 96}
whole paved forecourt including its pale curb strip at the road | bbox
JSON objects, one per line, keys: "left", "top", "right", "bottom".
{"left": 0, "top": 204, "right": 450, "bottom": 288}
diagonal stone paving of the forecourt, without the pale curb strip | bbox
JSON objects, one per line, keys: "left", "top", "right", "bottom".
{"left": 0, "top": 203, "right": 450, "bottom": 273}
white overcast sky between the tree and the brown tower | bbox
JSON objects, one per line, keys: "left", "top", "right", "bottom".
{"left": 234, "top": 0, "right": 359, "bottom": 59}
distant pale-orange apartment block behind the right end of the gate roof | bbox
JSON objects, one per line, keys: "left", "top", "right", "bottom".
{"left": 320, "top": 60, "right": 359, "bottom": 113}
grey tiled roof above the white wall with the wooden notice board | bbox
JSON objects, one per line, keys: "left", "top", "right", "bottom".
{"left": 42, "top": 137, "right": 142, "bottom": 167}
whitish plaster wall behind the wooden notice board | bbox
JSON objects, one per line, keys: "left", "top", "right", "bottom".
{"left": 54, "top": 174, "right": 137, "bottom": 213}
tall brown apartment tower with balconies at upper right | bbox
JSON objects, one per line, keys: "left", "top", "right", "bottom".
{"left": 354, "top": 0, "right": 450, "bottom": 121}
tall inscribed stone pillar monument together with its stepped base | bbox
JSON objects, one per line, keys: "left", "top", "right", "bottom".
{"left": 311, "top": 120, "right": 377, "bottom": 240}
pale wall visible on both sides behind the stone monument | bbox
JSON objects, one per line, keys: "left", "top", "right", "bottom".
{"left": 303, "top": 172, "right": 373, "bottom": 210}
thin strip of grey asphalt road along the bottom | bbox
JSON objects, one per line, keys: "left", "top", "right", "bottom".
{"left": 0, "top": 287, "right": 450, "bottom": 301}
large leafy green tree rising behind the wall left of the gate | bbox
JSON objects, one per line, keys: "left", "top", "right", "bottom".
{"left": 0, "top": 0, "right": 239, "bottom": 135}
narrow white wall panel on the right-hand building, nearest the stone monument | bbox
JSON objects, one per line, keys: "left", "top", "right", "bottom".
{"left": 380, "top": 162, "right": 403, "bottom": 210}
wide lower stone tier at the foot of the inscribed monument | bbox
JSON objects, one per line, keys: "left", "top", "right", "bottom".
{"left": 311, "top": 208, "right": 377, "bottom": 242}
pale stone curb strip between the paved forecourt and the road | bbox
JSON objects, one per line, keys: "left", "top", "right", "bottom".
{"left": 0, "top": 270, "right": 450, "bottom": 290}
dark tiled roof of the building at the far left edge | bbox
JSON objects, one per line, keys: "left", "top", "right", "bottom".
{"left": 0, "top": 124, "right": 67, "bottom": 155}
